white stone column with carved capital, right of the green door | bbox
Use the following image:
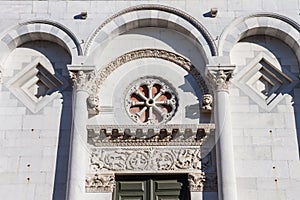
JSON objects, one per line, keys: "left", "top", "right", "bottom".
{"left": 207, "top": 66, "right": 237, "bottom": 200}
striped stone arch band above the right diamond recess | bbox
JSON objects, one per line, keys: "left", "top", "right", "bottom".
{"left": 219, "top": 13, "right": 300, "bottom": 61}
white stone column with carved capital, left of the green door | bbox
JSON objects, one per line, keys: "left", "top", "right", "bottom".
{"left": 67, "top": 70, "right": 93, "bottom": 200}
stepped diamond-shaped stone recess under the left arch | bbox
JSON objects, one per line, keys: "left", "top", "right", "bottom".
{"left": 6, "top": 57, "right": 67, "bottom": 113}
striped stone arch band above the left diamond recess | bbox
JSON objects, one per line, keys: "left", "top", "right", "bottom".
{"left": 0, "top": 20, "right": 83, "bottom": 62}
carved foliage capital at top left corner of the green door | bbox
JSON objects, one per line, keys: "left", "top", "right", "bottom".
{"left": 85, "top": 174, "right": 115, "bottom": 192}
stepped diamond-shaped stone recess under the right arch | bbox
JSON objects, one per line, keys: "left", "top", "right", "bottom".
{"left": 235, "top": 52, "right": 299, "bottom": 111}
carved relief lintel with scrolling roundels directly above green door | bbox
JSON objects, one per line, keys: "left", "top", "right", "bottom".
{"left": 89, "top": 147, "right": 201, "bottom": 173}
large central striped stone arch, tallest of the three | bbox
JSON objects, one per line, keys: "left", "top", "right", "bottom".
{"left": 84, "top": 4, "right": 218, "bottom": 58}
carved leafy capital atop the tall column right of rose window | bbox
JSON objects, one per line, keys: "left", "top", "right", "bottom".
{"left": 206, "top": 66, "right": 235, "bottom": 92}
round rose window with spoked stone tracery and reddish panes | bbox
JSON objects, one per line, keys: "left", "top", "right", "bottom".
{"left": 126, "top": 78, "right": 177, "bottom": 124}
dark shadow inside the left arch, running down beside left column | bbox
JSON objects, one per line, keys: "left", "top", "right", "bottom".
{"left": 22, "top": 41, "right": 72, "bottom": 200}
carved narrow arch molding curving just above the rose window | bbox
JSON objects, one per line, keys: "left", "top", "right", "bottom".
{"left": 95, "top": 49, "right": 209, "bottom": 94}
